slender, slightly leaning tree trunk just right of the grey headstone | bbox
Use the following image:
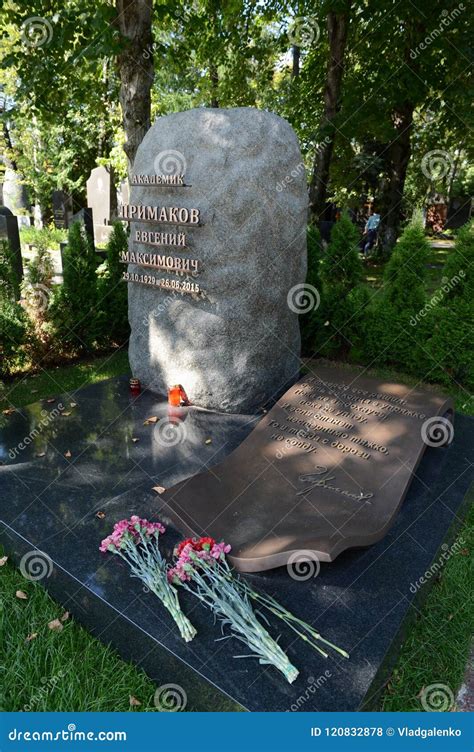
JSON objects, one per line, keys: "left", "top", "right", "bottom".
{"left": 309, "top": 7, "right": 351, "bottom": 222}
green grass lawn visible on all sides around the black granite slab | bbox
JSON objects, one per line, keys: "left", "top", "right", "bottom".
{"left": 0, "top": 352, "right": 474, "bottom": 711}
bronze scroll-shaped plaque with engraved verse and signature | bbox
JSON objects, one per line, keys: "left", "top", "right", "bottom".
{"left": 163, "top": 363, "right": 453, "bottom": 572}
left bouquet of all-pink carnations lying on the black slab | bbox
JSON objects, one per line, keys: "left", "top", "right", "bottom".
{"left": 100, "top": 515, "right": 196, "bottom": 642}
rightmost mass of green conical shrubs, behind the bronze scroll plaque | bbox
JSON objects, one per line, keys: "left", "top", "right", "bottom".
{"left": 361, "top": 214, "right": 474, "bottom": 388}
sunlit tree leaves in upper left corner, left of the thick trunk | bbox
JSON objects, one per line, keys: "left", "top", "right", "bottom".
{"left": 0, "top": 0, "right": 120, "bottom": 218}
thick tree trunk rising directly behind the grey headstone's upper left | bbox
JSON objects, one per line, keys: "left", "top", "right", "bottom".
{"left": 116, "top": 0, "right": 154, "bottom": 174}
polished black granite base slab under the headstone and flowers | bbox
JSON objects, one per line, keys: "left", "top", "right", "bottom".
{"left": 0, "top": 377, "right": 474, "bottom": 711}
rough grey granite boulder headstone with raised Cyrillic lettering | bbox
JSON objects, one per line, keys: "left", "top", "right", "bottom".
{"left": 128, "top": 108, "right": 307, "bottom": 412}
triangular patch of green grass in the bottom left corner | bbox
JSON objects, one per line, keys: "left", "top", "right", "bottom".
{"left": 0, "top": 563, "right": 156, "bottom": 711}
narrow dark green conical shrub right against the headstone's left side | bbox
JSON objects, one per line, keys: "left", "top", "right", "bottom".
{"left": 97, "top": 222, "right": 130, "bottom": 346}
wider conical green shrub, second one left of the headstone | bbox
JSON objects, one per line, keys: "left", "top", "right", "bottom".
{"left": 50, "top": 222, "right": 98, "bottom": 353}
